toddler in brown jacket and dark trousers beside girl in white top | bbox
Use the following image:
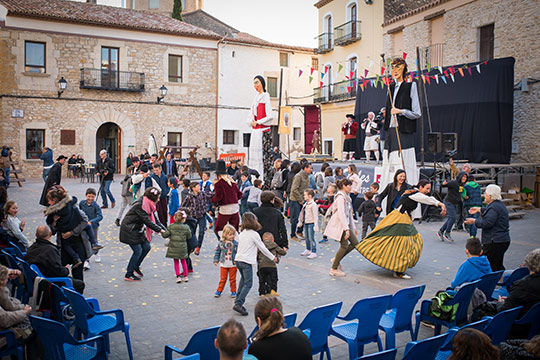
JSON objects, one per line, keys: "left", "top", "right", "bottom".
{"left": 257, "top": 232, "right": 287, "bottom": 297}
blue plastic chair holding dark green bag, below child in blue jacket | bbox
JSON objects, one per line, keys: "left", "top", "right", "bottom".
{"left": 416, "top": 280, "right": 480, "bottom": 335}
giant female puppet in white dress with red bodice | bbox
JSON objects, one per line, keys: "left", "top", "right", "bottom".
{"left": 248, "top": 75, "right": 274, "bottom": 188}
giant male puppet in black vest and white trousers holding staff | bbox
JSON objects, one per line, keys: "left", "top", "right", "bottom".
{"left": 381, "top": 58, "right": 421, "bottom": 212}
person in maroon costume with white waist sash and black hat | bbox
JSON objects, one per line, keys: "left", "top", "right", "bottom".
{"left": 211, "top": 160, "right": 242, "bottom": 236}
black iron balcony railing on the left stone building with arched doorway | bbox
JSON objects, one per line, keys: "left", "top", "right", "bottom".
{"left": 80, "top": 69, "right": 144, "bottom": 92}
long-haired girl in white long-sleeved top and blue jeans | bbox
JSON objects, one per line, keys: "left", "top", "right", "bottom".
{"left": 233, "top": 212, "right": 278, "bottom": 316}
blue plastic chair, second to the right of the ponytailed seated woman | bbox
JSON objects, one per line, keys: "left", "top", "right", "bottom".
{"left": 330, "top": 295, "right": 392, "bottom": 360}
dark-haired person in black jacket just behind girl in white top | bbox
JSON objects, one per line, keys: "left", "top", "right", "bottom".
{"left": 253, "top": 190, "right": 289, "bottom": 249}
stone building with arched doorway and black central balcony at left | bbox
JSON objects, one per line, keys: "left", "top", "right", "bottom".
{"left": 0, "top": 0, "right": 219, "bottom": 177}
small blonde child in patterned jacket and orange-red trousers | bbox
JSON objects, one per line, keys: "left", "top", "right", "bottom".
{"left": 214, "top": 224, "right": 238, "bottom": 298}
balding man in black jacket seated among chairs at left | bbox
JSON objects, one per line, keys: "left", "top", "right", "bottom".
{"left": 24, "top": 225, "right": 84, "bottom": 294}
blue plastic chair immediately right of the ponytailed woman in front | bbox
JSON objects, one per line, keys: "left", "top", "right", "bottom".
{"left": 298, "top": 301, "right": 343, "bottom": 360}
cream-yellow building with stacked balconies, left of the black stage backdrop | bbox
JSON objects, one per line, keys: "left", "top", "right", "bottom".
{"left": 314, "top": 0, "right": 383, "bottom": 158}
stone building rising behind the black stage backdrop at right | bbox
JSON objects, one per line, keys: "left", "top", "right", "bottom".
{"left": 383, "top": 0, "right": 540, "bottom": 162}
